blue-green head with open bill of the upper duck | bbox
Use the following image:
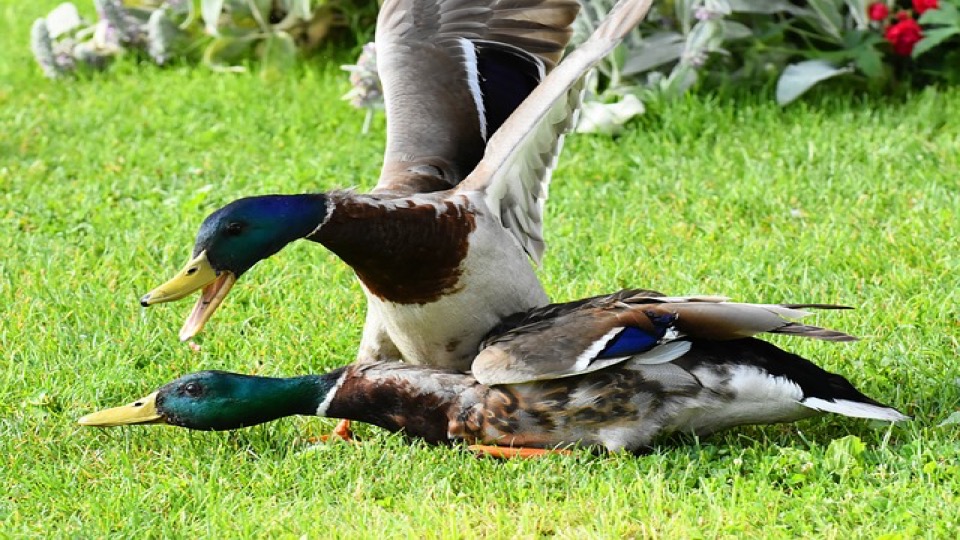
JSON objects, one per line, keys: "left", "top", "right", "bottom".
{"left": 140, "top": 195, "right": 327, "bottom": 341}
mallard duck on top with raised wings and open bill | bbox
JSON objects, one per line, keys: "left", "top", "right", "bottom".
{"left": 141, "top": 0, "right": 650, "bottom": 370}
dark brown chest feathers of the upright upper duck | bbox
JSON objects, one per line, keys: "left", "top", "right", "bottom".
{"left": 311, "top": 196, "right": 476, "bottom": 304}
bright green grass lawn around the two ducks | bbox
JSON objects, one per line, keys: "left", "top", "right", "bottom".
{"left": 0, "top": 2, "right": 960, "bottom": 538}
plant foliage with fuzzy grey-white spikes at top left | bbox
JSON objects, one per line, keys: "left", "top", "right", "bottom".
{"left": 31, "top": 0, "right": 376, "bottom": 78}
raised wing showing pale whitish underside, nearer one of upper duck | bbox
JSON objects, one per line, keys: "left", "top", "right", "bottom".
{"left": 458, "top": 0, "right": 652, "bottom": 262}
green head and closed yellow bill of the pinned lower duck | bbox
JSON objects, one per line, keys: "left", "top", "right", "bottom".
{"left": 79, "top": 371, "right": 337, "bottom": 431}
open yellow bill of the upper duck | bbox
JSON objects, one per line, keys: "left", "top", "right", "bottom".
{"left": 140, "top": 251, "right": 237, "bottom": 341}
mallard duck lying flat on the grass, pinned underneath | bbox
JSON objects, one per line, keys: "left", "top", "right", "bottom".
{"left": 80, "top": 290, "right": 908, "bottom": 456}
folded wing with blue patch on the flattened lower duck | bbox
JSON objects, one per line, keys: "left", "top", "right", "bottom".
{"left": 472, "top": 290, "right": 855, "bottom": 384}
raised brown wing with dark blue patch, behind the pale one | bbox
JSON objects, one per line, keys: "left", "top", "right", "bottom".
{"left": 376, "top": 0, "right": 579, "bottom": 194}
